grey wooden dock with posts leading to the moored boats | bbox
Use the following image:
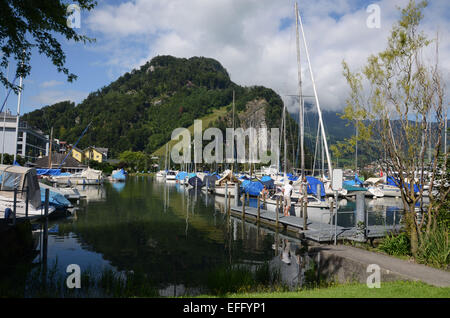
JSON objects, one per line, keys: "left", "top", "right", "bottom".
{"left": 230, "top": 205, "right": 400, "bottom": 243}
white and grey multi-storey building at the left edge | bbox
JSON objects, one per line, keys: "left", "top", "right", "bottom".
{"left": 0, "top": 111, "right": 54, "bottom": 161}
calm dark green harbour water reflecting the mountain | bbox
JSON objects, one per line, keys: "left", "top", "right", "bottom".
{"left": 0, "top": 177, "right": 401, "bottom": 296}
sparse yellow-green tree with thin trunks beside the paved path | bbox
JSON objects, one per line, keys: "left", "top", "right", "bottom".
{"left": 343, "top": 1, "right": 450, "bottom": 255}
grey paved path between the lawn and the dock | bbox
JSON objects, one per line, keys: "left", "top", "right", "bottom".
{"left": 317, "top": 245, "right": 450, "bottom": 287}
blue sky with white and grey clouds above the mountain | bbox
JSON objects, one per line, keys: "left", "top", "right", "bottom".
{"left": 0, "top": 0, "right": 450, "bottom": 117}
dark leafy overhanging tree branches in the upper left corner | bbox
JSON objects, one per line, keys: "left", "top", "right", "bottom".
{"left": 0, "top": 0, "right": 97, "bottom": 92}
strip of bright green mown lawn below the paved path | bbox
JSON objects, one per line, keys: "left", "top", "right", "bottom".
{"left": 203, "top": 281, "right": 450, "bottom": 298}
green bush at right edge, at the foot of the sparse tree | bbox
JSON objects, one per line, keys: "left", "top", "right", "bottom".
{"left": 416, "top": 225, "right": 450, "bottom": 269}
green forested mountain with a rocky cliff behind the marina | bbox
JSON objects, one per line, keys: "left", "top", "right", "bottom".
{"left": 23, "top": 56, "right": 298, "bottom": 161}
